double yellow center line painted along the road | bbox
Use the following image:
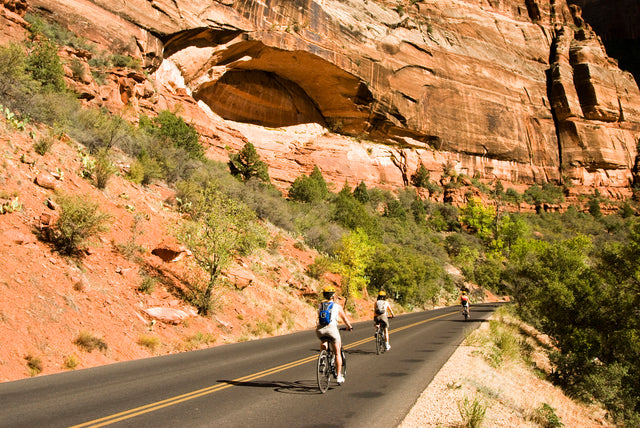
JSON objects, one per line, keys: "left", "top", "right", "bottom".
{"left": 70, "top": 312, "right": 457, "bottom": 428}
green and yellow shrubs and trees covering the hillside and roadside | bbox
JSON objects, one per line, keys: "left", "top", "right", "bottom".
{"left": 0, "top": 12, "right": 640, "bottom": 426}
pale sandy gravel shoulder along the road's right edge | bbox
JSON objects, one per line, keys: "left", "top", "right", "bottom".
{"left": 399, "top": 316, "right": 613, "bottom": 428}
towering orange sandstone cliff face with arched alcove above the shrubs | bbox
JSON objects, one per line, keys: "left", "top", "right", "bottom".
{"left": 26, "top": 0, "right": 640, "bottom": 196}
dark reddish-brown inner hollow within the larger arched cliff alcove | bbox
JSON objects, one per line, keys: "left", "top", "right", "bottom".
{"left": 194, "top": 70, "right": 325, "bottom": 128}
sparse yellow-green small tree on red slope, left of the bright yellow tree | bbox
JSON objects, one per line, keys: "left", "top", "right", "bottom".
{"left": 176, "top": 188, "right": 266, "bottom": 315}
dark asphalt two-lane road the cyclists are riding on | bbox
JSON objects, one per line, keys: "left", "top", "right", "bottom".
{"left": 0, "top": 305, "right": 496, "bottom": 428}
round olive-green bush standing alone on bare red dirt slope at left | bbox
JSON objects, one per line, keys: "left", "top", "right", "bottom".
{"left": 51, "top": 195, "right": 110, "bottom": 255}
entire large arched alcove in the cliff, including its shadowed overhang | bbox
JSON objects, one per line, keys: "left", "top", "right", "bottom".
{"left": 165, "top": 29, "right": 373, "bottom": 135}
